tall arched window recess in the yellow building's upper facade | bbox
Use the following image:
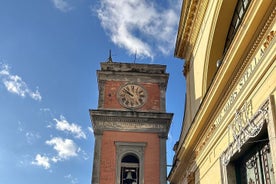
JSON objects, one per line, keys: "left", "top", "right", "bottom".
{"left": 202, "top": 0, "right": 252, "bottom": 94}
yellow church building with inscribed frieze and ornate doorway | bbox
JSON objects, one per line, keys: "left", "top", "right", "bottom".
{"left": 168, "top": 0, "right": 276, "bottom": 184}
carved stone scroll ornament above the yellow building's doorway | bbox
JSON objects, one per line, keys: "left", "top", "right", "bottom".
{"left": 221, "top": 102, "right": 268, "bottom": 165}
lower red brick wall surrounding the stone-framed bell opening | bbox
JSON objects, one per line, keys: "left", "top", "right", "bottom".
{"left": 100, "top": 131, "right": 160, "bottom": 184}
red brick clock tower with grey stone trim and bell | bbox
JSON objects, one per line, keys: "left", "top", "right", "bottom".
{"left": 90, "top": 60, "right": 173, "bottom": 184}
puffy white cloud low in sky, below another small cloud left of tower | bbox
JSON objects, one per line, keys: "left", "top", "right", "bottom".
{"left": 46, "top": 137, "right": 80, "bottom": 162}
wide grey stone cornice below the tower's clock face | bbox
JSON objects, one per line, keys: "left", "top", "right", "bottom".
{"left": 90, "top": 110, "right": 173, "bottom": 137}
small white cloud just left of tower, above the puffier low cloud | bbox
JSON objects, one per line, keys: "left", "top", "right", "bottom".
{"left": 54, "top": 116, "right": 86, "bottom": 139}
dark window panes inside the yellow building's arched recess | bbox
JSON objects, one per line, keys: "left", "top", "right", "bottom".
{"left": 224, "top": 0, "right": 251, "bottom": 53}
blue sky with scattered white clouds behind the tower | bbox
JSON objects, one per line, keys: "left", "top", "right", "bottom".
{"left": 0, "top": 0, "right": 185, "bottom": 184}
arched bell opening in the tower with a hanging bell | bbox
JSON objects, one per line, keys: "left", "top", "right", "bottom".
{"left": 120, "top": 154, "right": 139, "bottom": 184}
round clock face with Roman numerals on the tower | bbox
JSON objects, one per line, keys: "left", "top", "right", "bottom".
{"left": 117, "top": 84, "right": 147, "bottom": 109}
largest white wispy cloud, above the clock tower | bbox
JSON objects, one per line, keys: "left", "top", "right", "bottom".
{"left": 96, "top": 0, "right": 180, "bottom": 58}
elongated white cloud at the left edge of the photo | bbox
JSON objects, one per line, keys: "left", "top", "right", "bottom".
{"left": 0, "top": 64, "right": 42, "bottom": 101}
